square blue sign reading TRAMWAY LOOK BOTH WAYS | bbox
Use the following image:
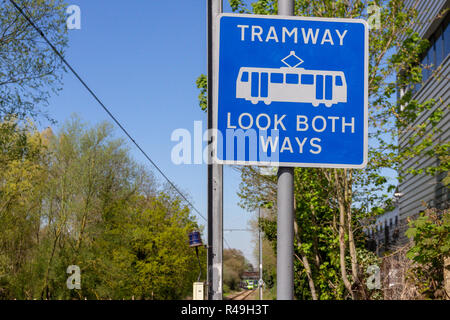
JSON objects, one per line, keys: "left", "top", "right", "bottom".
{"left": 214, "top": 14, "right": 368, "bottom": 168}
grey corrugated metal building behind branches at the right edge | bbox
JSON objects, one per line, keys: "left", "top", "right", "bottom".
{"left": 398, "top": 0, "right": 450, "bottom": 238}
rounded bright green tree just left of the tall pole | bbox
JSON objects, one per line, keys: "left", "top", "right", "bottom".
{"left": 96, "top": 194, "right": 205, "bottom": 299}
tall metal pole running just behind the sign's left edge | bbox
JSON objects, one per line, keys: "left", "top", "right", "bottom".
{"left": 207, "top": 0, "right": 223, "bottom": 300}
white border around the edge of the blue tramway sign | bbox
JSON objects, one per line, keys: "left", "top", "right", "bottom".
{"left": 212, "top": 13, "right": 369, "bottom": 169}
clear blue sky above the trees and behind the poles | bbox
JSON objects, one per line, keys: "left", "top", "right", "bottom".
{"left": 47, "top": 0, "right": 255, "bottom": 262}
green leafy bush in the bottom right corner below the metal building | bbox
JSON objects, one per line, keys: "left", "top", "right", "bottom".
{"left": 406, "top": 210, "right": 450, "bottom": 299}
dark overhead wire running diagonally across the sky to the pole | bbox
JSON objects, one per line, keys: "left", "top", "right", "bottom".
{"left": 9, "top": 0, "right": 208, "bottom": 221}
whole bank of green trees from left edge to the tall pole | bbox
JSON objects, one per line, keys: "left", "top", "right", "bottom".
{"left": 0, "top": 118, "right": 206, "bottom": 299}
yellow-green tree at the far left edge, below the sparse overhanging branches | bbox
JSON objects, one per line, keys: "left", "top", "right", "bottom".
{"left": 0, "top": 120, "right": 47, "bottom": 298}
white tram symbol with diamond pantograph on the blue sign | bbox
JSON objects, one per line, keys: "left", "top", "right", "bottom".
{"left": 236, "top": 51, "right": 347, "bottom": 107}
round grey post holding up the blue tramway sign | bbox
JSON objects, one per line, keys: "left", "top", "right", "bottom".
{"left": 277, "top": 0, "right": 294, "bottom": 300}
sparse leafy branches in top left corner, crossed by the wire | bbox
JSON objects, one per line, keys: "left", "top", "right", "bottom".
{"left": 0, "top": 0, "right": 67, "bottom": 119}
